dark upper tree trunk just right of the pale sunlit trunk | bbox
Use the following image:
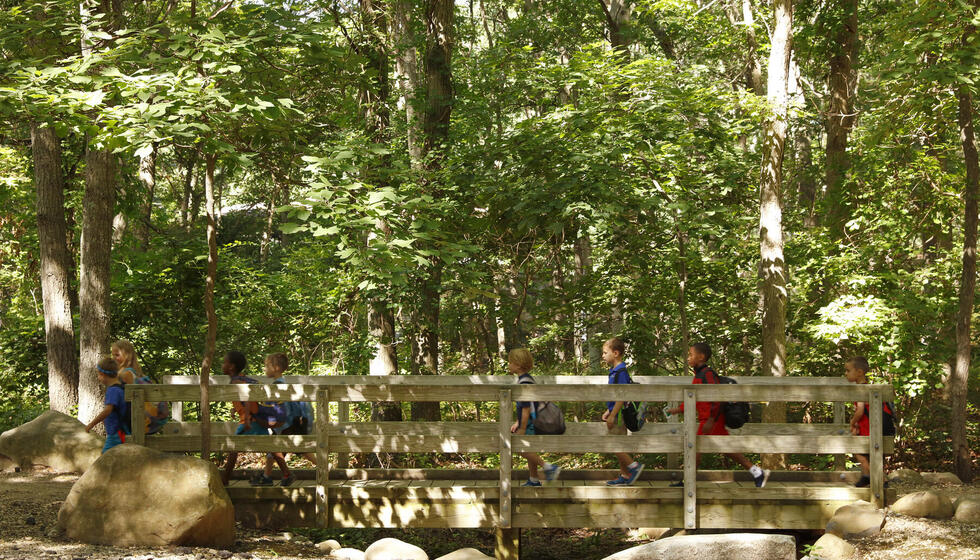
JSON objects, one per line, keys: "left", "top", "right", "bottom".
{"left": 824, "top": 0, "right": 858, "bottom": 234}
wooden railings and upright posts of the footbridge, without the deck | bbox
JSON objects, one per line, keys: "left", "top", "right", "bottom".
{"left": 126, "top": 376, "right": 894, "bottom": 528}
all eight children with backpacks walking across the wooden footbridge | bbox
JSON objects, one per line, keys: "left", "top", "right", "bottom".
{"left": 85, "top": 338, "right": 895, "bottom": 488}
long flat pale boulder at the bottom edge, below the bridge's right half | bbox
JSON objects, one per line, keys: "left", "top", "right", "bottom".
{"left": 604, "top": 533, "right": 796, "bottom": 560}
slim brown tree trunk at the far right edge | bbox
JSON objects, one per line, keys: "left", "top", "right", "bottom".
{"left": 949, "top": 13, "right": 980, "bottom": 482}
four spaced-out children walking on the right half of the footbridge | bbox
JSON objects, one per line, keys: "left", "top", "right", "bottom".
{"left": 508, "top": 338, "right": 895, "bottom": 488}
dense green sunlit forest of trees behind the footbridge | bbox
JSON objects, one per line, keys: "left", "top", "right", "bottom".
{"left": 0, "top": 0, "right": 980, "bottom": 479}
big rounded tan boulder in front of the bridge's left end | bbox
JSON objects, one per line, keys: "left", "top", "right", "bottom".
{"left": 58, "top": 444, "right": 235, "bottom": 548}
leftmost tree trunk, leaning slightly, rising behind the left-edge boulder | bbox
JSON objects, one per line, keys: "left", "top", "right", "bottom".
{"left": 31, "top": 123, "right": 78, "bottom": 414}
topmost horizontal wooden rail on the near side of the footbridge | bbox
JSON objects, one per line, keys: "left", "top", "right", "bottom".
{"left": 126, "top": 382, "right": 894, "bottom": 402}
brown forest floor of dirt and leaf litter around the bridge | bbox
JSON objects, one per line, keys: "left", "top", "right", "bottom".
{"left": 0, "top": 471, "right": 980, "bottom": 560}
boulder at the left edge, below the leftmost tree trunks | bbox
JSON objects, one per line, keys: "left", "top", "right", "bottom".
{"left": 0, "top": 410, "right": 105, "bottom": 473}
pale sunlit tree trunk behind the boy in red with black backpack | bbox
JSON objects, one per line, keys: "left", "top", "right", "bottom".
{"left": 759, "top": 0, "right": 793, "bottom": 469}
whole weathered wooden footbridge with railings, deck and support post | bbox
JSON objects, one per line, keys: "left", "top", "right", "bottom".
{"left": 126, "top": 376, "right": 894, "bottom": 559}
